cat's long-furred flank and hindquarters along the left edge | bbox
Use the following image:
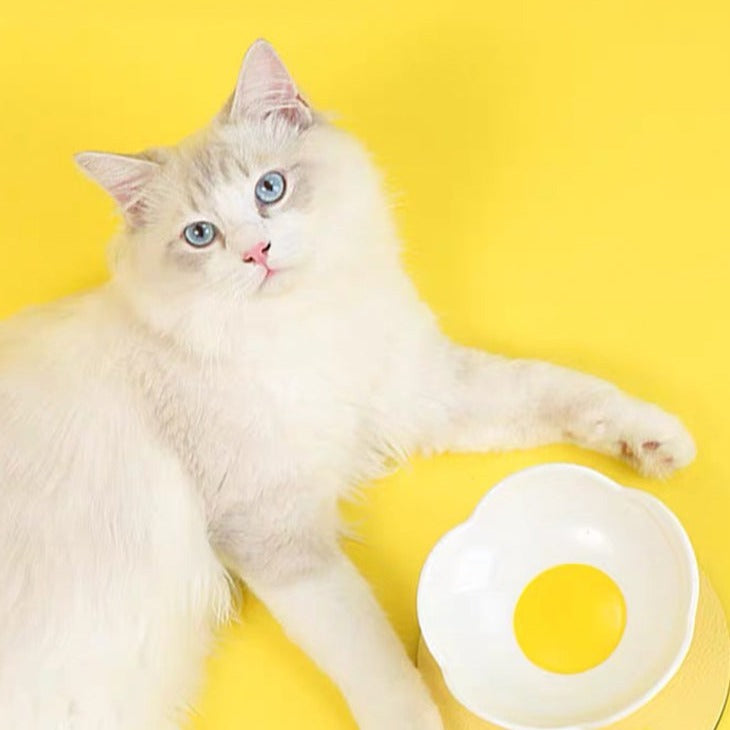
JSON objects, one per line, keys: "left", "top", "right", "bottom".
{"left": 0, "top": 293, "right": 230, "bottom": 730}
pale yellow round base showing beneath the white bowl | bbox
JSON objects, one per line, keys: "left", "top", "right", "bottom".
{"left": 418, "top": 573, "right": 730, "bottom": 730}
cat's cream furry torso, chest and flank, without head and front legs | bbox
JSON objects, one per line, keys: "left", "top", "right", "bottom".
{"left": 0, "top": 235, "right": 435, "bottom": 730}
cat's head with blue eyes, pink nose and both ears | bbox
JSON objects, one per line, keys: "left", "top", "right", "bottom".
{"left": 76, "top": 40, "right": 392, "bottom": 330}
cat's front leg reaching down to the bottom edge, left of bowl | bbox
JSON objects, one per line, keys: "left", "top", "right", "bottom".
{"left": 215, "top": 512, "right": 443, "bottom": 730}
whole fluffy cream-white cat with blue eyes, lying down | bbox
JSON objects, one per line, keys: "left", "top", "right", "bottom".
{"left": 0, "top": 40, "right": 695, "bottom": 730}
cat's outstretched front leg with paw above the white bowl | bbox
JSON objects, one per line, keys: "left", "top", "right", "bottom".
{"left": 412, "top": 343, "right": 695, "bottom": 477}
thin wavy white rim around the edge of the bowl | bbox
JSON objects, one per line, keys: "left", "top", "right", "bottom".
{"left": 416, "top": 461, "right": 700, "bottom": 730}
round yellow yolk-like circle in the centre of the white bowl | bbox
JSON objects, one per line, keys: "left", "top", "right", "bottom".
{"left": 514, "top": 564, "right": 626, "bottom": 674}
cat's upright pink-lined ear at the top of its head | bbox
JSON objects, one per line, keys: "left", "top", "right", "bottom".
{"left": 226, "top": 39, "right": 312, "bottom": 129}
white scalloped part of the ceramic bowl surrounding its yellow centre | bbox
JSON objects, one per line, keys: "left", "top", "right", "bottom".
{"left": 418, "top": 464, "right": 699, "bottom": 730}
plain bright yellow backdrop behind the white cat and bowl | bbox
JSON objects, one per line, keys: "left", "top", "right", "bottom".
{"left": 0, "top": 0, "right": 730, "bottom": 730}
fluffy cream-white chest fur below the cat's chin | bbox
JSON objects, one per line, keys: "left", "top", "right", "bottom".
{"left": 130, "top": 278, "right": 420, "bottom": 523}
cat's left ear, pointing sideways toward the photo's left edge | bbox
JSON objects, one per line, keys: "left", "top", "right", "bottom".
{"left": 74, "top": 152, "right": 160, "bottom": 226}
